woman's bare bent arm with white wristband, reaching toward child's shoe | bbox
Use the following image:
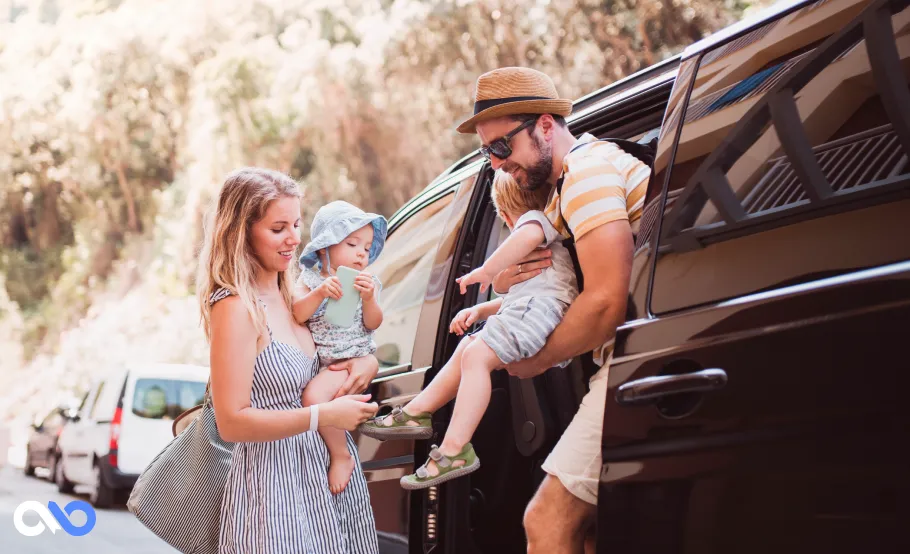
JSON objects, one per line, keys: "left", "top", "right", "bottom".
{"left": 209, "top": 296, "right": 376, "bottom": 442}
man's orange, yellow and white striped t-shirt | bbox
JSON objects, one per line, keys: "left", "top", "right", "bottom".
{"left": 544, "top": 133, "right": 651, "bottom": 367}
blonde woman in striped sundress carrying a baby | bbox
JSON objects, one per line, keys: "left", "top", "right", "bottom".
{"left": 197, "top": 168, "right": 378, "bottom": 554}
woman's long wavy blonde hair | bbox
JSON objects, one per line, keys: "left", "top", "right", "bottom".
{"left": 196, "top": 167, "right": 302, "bottom": 340}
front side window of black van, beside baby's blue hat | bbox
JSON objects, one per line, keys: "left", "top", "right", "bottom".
{"left": 370, "top": 190, "right": 453, "bottom": 367}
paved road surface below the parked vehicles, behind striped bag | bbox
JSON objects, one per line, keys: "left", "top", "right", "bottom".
{"left": 0, "top": 465, "right": 177, "bottom": 554}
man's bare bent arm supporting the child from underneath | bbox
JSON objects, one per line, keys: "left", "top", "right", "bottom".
{"left": 506, "top": 220, "right": 633, "bottom": 378}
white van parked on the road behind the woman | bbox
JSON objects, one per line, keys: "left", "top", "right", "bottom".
{"left": 54, "top": 364, "right": 209, "bottom": 508}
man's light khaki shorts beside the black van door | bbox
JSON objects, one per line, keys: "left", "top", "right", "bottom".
{"left": 543, "top": 360, "right": 611, "bottom": 505}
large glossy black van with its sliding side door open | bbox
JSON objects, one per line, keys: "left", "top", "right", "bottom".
{"left": 357, "top": 0, "right": 910, "bottom": 554}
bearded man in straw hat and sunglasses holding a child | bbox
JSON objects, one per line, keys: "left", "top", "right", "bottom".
{"left": 458, "top": 67, "right": 651, "bottom": 554}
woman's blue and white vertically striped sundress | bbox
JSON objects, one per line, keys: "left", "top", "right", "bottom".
{"left": 212, "top": 289, "right": 379, "bottom": 554}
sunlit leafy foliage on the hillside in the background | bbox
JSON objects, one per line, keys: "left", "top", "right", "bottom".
{"left": 0, "top": 0, "right": 760, "bottom": 420}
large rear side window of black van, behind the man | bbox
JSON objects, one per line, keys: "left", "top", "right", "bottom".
{"left": 651, "top": 2, "right": 910, "bottom": 313}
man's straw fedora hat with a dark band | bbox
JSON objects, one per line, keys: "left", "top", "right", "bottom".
{"left": 458, "top": 67, "right": 572, "bottom": 134}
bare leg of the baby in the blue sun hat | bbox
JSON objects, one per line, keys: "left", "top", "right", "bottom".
{"left": 302, "top": 369, "right": 354, "bottom": 494}
